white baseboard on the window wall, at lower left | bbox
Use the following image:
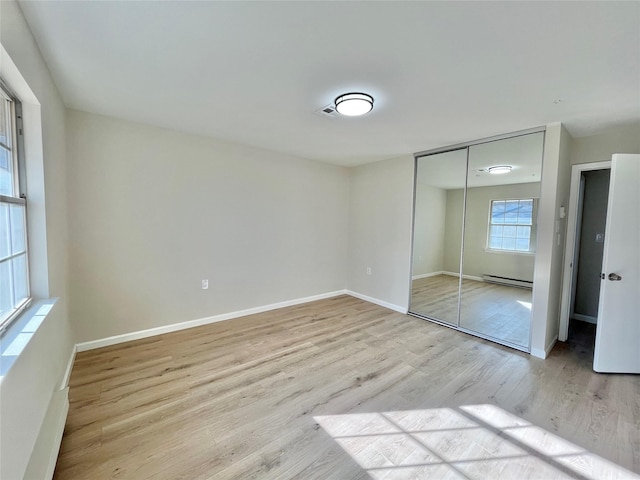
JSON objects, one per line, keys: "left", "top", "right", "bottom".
{"left": 24, "top": 387, "right": 69, "bottom": 480}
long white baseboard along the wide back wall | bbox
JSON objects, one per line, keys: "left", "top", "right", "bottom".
{"left": 76, "top": 290, "right": 349, "bottom": 352}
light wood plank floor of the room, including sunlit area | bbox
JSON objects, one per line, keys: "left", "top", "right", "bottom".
{"left": 55, "top": 296, "right": 640, "bottom": 480}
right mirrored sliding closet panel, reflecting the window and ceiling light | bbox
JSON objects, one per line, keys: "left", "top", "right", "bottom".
{"left": 460, "top": 132, "right": 544, "bottom": 349}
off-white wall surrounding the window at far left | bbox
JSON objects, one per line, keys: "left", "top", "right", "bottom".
{"left": 0, "top": 1, "right": 75, "bottom": 479}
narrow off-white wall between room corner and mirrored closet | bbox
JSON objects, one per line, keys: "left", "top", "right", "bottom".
{"left": 347, "top": 155, "right": 414, "bottom": 311}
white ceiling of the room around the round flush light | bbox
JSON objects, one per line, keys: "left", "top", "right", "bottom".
{"left": 15, "top": 0, "right": 640, "bottom": 166}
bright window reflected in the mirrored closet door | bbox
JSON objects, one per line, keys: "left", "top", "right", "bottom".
{"left": 487, "top": 198, "right": 534, "bottom": 252}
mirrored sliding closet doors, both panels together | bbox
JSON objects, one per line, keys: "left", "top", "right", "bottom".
{"left": 409, "top": 131, "right": 544, "bottom": 351}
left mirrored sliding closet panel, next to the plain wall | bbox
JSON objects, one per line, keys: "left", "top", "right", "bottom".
{"left": 410, "top": 148, "right": 467, "bottom": 326}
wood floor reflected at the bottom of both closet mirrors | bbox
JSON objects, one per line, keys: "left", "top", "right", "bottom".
{"left": 411, "top": 275, "right": 531, "bottom": 348}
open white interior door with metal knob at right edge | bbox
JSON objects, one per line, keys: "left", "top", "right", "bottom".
{"left": 593, "top": 154, "right": 640, "bottom": 373}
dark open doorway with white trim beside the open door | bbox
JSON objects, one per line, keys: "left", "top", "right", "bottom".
{"left": 559, "top": 162, "right": 611, "bottom": 344}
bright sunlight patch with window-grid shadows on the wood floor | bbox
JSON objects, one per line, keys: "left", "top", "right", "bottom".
{"left": 314, "top": 405, "right": 640, "bottom": 480}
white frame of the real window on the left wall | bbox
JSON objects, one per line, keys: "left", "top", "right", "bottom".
{"left": 0, "top": 79, "right": 32, "bottom": 334}
